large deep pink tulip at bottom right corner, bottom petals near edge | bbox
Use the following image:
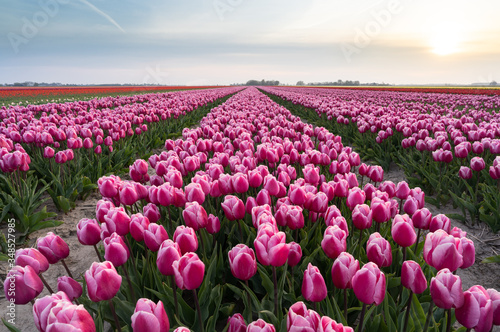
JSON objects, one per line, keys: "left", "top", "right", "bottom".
{"left": 455, "top": 286, "right": 493, "bottom": 332}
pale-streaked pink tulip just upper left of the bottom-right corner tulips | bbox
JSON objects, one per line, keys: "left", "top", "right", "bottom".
{"left": 429, "top": 268, "right": 464, "bottom": 309}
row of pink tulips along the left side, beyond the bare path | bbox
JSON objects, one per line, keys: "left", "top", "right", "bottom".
{"left": 0, "top": 88, "right": 242, "bottom": 236}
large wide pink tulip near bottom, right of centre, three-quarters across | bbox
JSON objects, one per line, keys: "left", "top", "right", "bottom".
{"left": 352, "top": 262, "right": 386, "bottom": 305}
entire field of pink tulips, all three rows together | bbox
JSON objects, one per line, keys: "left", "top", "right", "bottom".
{"left": 0, "top": 87, "right": 500, "bottom": 332}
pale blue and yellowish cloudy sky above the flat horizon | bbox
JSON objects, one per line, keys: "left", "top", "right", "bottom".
{"left": 0, "top": 0, "right": 500, "bottom": 85}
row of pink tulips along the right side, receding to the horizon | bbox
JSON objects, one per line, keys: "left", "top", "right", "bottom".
{"left": 264, "top": 87, "right": 500, "bottom": 232}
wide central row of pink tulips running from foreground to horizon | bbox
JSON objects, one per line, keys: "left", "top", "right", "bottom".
{"left": 4, "top": 88, "right": 500, "bottom": 332}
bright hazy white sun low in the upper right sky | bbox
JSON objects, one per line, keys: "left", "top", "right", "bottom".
{"left": 430, "top": 23, "right": 461, "bottom": 56}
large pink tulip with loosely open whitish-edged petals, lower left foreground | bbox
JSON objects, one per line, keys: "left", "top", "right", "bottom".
{"left": 85, "top": 261, "right": 122, "bottom": 302}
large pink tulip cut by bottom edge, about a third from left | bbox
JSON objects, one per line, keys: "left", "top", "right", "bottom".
{"left": 131, "top": 298, "right": 170, "bottom": 332}
